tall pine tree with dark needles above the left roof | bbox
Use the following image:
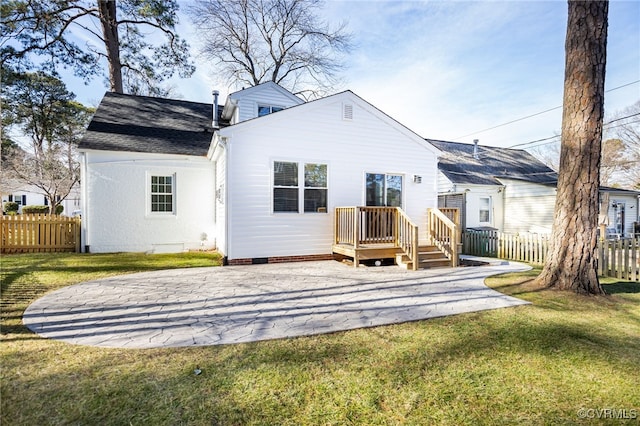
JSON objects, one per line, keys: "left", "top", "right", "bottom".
{"left": 0, "top": 0, "right": 194, "bottom": 95}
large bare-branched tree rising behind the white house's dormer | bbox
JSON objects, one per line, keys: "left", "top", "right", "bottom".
{"left": 190, "top": 0, "right": 351, "bottom": 97}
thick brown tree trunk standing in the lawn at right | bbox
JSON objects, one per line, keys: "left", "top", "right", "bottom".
{"left": 537, "top": 0, "right": 609, "bottom": 294}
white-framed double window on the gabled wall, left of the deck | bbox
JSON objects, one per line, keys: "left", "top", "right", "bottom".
{"left": 273, "top": 161, "right": 327, "bottom": 213}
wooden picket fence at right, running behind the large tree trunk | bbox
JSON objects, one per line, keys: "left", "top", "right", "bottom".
{"left": 462, "top": 229, "right": 640, "bottom": 281}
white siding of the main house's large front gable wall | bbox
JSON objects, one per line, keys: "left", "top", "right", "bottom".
{"left": 221, "top": 92, "right": 437, "bottom": 259}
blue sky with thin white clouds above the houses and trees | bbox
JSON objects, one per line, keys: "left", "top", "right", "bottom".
{"left": 68, "top": 0, "right": 640, "bottom": 147}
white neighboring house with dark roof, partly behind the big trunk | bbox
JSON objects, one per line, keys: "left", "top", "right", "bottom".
{"left": 428, "top": 139, "right": 640, "bottom": 236}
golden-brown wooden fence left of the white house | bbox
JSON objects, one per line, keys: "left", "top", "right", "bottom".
{"left": 0, "top": 214, "right": 80, "bottom": 253}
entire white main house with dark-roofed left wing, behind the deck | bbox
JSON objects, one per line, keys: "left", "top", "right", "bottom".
{"left": 79, "top": 83, "right": 439, "bottom": 263}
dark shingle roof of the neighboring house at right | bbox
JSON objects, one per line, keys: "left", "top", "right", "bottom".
{"left": 427, "top": 139, "right": 558, "bottom": 185}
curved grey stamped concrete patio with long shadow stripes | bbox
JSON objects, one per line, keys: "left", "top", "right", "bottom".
{"left": 23, "top": 259, "right": 529, "bottom": 348}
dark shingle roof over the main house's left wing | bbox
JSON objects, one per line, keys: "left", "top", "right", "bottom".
{"left": 79, "top": 93, "right": 219, "bottom": 156}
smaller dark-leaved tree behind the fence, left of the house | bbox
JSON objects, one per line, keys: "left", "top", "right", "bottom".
{"left": 2, "top": 71, "right": 93, "bottom": 215}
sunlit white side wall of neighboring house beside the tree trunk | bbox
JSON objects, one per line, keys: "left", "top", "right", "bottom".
{"left": 501, "top": 179, "right": 556, "bottom": 233}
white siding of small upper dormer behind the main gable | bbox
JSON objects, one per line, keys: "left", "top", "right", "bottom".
{"left": 230, "top": 83, "right": 303, "bottom": 121}
